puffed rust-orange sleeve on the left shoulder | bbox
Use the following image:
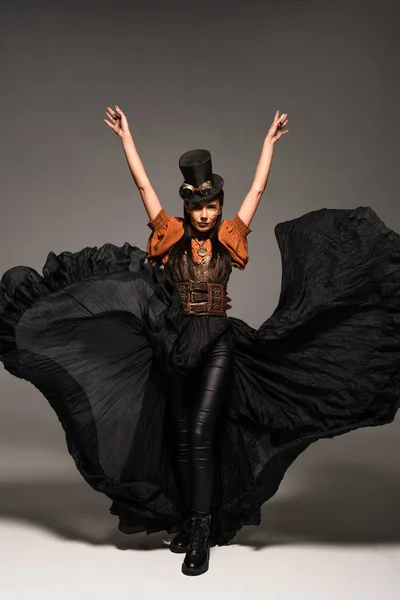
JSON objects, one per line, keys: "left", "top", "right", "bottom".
{"left": 146, "top": 208, "right": 183, "bottom": 266}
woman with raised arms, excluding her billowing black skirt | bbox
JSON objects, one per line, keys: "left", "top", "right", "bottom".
{"left": 104, "top": 106, "right": 289, "bottom": 575}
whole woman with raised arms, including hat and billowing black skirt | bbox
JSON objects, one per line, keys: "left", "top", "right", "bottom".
{"left": 0, "top": 107, "right": 400, "bottom": 575}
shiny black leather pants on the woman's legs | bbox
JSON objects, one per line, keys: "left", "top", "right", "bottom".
{"left": 171, "top": 331, "right": 232, "bottom": 515}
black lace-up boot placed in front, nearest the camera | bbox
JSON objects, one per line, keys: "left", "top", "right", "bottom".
{"left": 182, "top": 515, "right": 211, "bottom": 575}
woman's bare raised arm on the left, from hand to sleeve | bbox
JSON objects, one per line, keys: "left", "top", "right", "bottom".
{"left": 104, "top": 105, "right": 162, "bottom": 220}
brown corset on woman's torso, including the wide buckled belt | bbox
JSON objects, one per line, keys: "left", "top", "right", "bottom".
{"left": 164, "top": 253, "right": 232, "bottom": 316}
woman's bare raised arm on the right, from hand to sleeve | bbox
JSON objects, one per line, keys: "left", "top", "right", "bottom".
{"left": 238, "top": 110, "right": 289, "bottom": 226}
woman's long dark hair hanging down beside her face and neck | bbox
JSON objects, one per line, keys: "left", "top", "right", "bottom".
{"left": 170, "top": 190, "right": 230, "bottom": 277}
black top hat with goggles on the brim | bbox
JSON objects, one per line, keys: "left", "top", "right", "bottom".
{"left": 179, "top": 150, "right": 224, "bottom": 202}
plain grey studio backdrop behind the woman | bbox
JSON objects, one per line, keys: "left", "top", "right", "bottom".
{"left": 0, "top": 0, "right": 400, "bottom": 542}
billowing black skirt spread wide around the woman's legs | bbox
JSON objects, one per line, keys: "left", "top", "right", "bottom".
{"left": 0, "top": 207, "right": 400, "bottom": 545}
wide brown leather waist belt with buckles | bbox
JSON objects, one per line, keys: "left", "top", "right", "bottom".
{"left": 175, "top": 281, "right": 232, "bottom": 317}
